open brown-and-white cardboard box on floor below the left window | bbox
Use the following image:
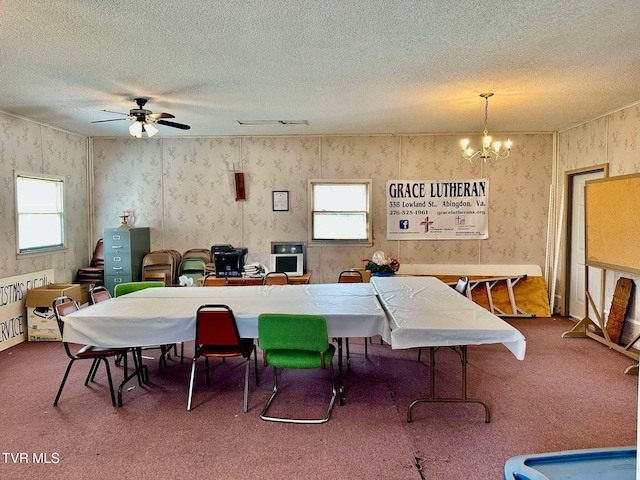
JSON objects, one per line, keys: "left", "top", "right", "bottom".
{"left": 25, "top": 283, "right": 82, "bottom": 342}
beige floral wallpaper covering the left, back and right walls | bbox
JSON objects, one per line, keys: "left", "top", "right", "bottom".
{"left": 5, "top": 100, "right": 640, "bottom": 342}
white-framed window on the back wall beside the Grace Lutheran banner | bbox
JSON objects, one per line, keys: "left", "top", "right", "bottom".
{"left": 308, "top": 179, "right": 372, "bottom": 245}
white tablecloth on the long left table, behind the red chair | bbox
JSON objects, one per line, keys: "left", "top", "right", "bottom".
{"left": 64, "top": 284, "right": 391, "bottom": 347}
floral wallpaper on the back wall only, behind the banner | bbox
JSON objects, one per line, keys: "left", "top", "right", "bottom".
{"left": 92, "top": 134, "right": 553, "bottom": 283}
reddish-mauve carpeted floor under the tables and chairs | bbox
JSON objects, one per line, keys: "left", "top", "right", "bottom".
{"left": 0, "top": 318, "right": 638, "bottom": 480}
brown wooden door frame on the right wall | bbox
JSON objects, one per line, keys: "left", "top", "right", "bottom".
{"left": 558, "top": 163, "right": 609, "bottom": 316}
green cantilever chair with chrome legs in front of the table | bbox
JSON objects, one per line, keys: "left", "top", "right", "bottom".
{"left": 258, "top": 313, "right": 336, "bottom": 423}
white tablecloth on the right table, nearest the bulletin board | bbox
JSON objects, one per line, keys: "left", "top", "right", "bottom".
{"left": 371, "top": 277, "right": 526, "bottom": 360}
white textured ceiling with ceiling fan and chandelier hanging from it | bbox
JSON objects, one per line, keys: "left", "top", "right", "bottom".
{"left": 0, "top": 0, "right": 640, "bottom": 136}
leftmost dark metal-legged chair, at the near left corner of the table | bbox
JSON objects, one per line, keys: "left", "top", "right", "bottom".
{"left": 53, "top": 295, "right": 132, "bottom": 407}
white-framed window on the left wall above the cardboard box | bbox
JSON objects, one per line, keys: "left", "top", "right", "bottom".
{"left": 15, "top": 172, "right": 65, "bottom": 253}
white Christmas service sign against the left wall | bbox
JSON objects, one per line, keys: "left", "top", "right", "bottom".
{"left": 0, "top": 269, "right": 54, "bottom": 351}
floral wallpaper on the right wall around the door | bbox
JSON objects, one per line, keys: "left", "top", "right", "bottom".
{"left": 555, "top": 105, "right": 640, "bottom": 341}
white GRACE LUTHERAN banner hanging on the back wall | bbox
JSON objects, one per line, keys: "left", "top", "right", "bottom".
{"left": 387, "top": 178, "right": 489, "bottom": 240}
